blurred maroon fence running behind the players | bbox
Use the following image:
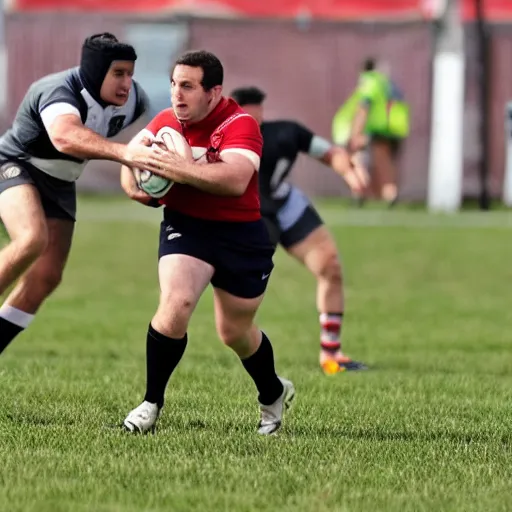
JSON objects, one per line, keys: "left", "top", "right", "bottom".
{"left": 1, "top": 13, "right": 512, "bottom": 200}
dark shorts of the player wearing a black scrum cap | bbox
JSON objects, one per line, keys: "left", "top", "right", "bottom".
{"left": 0, "top": 160, "right": 76, "bottom": 221}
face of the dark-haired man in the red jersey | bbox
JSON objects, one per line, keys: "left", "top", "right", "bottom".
{"left": 171, "top": 64, "right": 222, "bottom": 123}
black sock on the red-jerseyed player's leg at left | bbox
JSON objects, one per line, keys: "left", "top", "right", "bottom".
{"left": 144, "top": 324, "right": 187, "bottom": 408}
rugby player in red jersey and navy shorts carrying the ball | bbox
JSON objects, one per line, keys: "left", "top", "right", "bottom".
{"left": 121, "top": 51, "right": 295, "bottom": 435}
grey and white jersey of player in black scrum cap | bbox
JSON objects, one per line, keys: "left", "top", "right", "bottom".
{"left": 0, "top": 67, "right": 148, "bottom": 182}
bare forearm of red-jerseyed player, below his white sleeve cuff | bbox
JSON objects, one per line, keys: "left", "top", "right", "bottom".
{"left": 173, "top": 162, "right": 252, "bottom": 197}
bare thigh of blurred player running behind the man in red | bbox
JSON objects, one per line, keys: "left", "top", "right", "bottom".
{"left": 286, "top": 225, "right": 341, "bottom": 276}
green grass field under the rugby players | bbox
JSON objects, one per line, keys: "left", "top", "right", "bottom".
{"left": 0, "top": 198, "right": 512, "bottom": 512}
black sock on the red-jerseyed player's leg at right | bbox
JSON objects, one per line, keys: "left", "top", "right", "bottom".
{"left": 242, "top": 332, "right": 283, "bottom": 405}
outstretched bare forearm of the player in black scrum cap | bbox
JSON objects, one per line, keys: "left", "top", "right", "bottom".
{"left": 52, "top": 126, "right": 126, "bottom": 163}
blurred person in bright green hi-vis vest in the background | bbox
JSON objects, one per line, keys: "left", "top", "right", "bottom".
{"left": 332, "top": 58, "right": 410, "bottom": 206}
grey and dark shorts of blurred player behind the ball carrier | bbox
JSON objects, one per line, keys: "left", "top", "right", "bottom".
{"left": 263, "top": 186, "right": 323, "bottom": 249}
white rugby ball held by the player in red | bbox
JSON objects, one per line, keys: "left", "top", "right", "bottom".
{"left": 134, "top": 126, "right": 192, "bottom": 199}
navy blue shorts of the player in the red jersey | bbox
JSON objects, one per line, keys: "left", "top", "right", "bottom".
{"left": 158, "top": 208, "right": 274, "bottom": 299}
